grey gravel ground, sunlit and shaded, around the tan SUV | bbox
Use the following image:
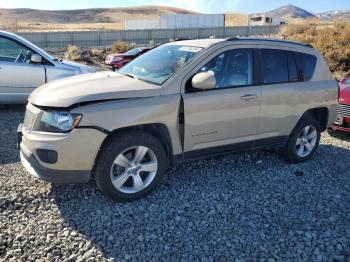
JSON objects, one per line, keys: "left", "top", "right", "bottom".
{"left": 0, "top": 107, "right": 350, "bottom": 261}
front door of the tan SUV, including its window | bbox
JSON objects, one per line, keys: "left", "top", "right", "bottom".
{"left": 183, "top": 48, "right": 260, "bottom": 157}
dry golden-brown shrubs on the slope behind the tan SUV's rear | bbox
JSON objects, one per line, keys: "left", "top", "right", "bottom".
{"left": 281, "top": 21, "right": 350, "bottom": 76}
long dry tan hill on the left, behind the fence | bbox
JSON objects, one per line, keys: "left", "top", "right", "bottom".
{"left": 0, "top": 6, "right": 195, "bottom": 31}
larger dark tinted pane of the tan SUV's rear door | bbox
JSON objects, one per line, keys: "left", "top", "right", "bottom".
{"left": 261, "top": 49, "right": 289, "bottom": 84}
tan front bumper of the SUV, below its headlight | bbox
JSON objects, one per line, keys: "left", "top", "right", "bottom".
{"left": 18, "top": 126, "right": 106, "bottom": 184}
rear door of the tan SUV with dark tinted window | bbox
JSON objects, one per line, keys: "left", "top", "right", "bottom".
{"left": 258, "top": 48, "right": 308, "bottom": 144}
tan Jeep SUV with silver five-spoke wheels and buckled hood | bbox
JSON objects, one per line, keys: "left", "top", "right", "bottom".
{"left": 19, "top": 38, "right": 338, "bottom": 201}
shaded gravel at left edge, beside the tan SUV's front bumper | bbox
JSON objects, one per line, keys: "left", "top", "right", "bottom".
{"left": 0, "top": 105, "right": 25, "bottom": 165}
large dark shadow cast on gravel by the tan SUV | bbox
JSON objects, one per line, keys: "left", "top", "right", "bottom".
{"left": 51, "top": 145, "right": 350, "bottom": 261}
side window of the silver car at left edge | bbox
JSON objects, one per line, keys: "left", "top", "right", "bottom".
{"left": 0, "top": 37, "right": 32, "bottom": 64}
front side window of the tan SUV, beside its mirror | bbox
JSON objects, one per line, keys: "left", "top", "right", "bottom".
{"left": 199, "top": 48, "right": 253, "bottom": 88}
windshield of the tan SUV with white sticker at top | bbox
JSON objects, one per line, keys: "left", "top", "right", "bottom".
{"left": 119, "top": 45, "right": 202, "bottom": 85}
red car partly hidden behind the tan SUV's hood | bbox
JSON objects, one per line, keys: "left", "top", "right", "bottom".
{"left": 105, "top": 47, "right": 151, "bottom": 71}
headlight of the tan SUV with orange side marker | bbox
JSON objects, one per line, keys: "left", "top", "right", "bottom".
{"left": 37, "top": 111, "right": 82, "bottom": 133}
